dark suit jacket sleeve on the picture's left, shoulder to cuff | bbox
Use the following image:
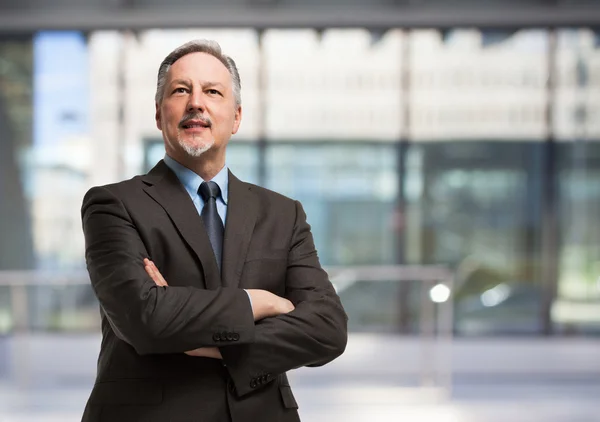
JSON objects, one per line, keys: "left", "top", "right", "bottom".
{"left": 81, "top": 187, "right": 255, "bottom": 354}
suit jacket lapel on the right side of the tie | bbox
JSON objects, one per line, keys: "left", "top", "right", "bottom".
{"left": 222, "top": 172, "right": 258, "bottom": 287}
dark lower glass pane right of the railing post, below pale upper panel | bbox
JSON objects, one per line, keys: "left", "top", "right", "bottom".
{"left": 405, "top": 141, "right": 543, "bottom": 335}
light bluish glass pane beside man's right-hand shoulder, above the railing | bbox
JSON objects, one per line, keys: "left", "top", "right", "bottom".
{"left": 267, "top": 143, "right": 398, "bottom": 265}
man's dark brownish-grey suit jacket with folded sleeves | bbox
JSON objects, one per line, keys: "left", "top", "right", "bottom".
{"left": 82, "top": 161, "right": 347, "bottom": 422}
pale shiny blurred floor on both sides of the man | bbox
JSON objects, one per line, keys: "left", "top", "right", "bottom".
{"left": 0, "top": 336, "right": 600, "bottom": 422}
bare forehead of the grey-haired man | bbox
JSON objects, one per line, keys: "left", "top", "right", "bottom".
{"left": 168, "top": 53, "right": 232, "bottom": 86}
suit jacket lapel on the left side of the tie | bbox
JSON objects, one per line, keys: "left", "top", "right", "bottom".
{"left": 142, "top": 160, "right": 221, "bottom": 290}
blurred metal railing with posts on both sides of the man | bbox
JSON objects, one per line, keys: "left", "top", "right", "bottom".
{"left": 0, "top": 265, "right": 454, "bottom": 397}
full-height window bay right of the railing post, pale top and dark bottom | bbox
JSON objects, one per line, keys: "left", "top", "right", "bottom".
{"left": 404, "top": 29, "right": 548, "bottom": 335}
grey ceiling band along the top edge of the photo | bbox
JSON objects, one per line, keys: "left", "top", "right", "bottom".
{"left": 0, "top": 0, "right": 600, "bottom": 34}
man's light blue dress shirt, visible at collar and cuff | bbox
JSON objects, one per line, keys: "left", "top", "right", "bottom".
{"left": 164, "top": 154, "right": 252, "bottom": 307}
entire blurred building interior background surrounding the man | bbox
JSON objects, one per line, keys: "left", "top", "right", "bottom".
{"left": 0, "top": 0, "right": 600, "bottom": 422}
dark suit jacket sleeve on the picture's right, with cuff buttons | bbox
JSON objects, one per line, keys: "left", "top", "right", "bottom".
{"left": 220, "top": 202, "right": 348, "bottom": 396}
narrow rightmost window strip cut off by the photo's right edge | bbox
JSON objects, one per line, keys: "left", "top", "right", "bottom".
{"left": 552, "top": 29, "right": 600, "bottom": 334}
